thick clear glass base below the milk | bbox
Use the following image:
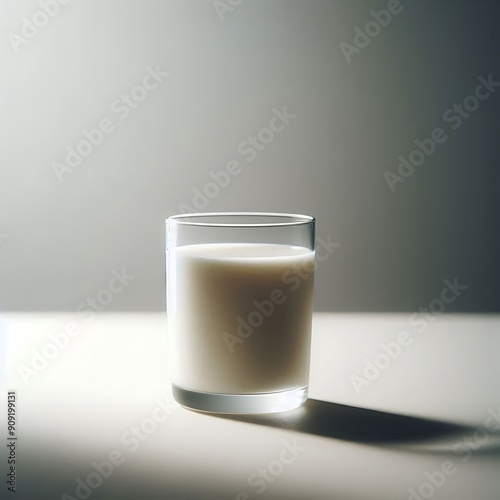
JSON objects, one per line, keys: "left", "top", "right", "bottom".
{"left": 172, "top": 384, "right": 309, "bottom": 414}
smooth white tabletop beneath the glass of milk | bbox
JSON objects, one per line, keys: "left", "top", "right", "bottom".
{"left": 0, "top": 313, "right": 500, "bottom": 500}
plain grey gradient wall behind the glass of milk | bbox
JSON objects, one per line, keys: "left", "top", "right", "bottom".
{"left": 0, "top": 0, "right": 500, "bottom": 312}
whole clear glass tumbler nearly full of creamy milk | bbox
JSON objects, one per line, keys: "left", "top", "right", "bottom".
{"left": 166, "top": 212, "right": 315, "bottom": 413}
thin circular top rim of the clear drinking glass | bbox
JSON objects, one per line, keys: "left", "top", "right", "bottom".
{"left": 166, "top": 212, "right": 316, "bottom": 227}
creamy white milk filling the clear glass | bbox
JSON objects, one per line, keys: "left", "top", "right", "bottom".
{"left": 168, "top": 243, "right": 314, "bottom": 394}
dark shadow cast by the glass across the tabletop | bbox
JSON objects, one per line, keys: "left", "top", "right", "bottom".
{"left": 212, "top": 399, "right": 474, "bottom": 444}
